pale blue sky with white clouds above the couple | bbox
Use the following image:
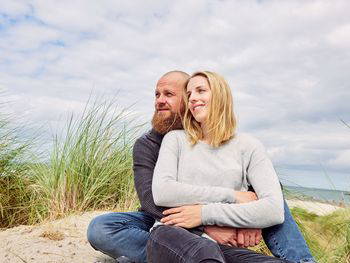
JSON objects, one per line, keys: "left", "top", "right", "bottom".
{"left": 0, "top": 0, "right": 350, "bottom": 190}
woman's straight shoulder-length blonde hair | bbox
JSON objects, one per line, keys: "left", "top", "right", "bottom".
{"left": 183, "top": 71, "right": 237, "bottom": 147}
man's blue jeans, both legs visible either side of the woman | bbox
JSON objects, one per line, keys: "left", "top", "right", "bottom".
{"left": 87, "top": 203, "right": 315, "bottom": 263}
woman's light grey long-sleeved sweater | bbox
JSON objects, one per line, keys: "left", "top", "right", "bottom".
{"left": 152, "top": 130, "right": 284, "bottom": 228}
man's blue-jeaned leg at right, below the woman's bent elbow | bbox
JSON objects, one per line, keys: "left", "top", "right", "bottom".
{"left": 262, "top": 201, "right": 316, "bottom": 262}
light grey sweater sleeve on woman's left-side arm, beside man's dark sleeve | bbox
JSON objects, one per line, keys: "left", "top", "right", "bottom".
{"left": 152, "top": 132, "right": 234, "bottom": 207}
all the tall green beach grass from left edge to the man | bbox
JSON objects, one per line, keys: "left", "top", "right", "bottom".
{"left": 0, "top": 100, "right": 142, "bottom": 228}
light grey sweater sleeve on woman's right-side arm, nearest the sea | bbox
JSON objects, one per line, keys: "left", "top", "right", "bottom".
{"left": 202, "top": 138, "right": 284, "bottom": 228}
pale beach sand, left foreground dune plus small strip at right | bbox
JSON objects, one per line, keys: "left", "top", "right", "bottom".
{"left": 0, "top": 200, "right": 343, "bottom": 263}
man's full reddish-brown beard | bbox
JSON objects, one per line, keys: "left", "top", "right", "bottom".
{"left": 152, "top": 111, "right": 183, "bottom": 134}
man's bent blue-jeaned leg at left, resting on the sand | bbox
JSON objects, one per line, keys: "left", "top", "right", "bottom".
{"left": 87, "top": 212, "right": 154, "bottom": 262}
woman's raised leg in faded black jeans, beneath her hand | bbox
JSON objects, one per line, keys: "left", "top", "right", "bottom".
{"left": 147, "top": 225, "right": 225, "bottom": 263}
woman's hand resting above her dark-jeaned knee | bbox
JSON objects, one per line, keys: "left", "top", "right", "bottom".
{"left": 160, "top": 205, "right": 202, "bottom": 228}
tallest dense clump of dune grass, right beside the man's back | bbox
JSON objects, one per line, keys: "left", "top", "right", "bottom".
{"left": 31, "top": 102, "right": 138, "bottom": 222}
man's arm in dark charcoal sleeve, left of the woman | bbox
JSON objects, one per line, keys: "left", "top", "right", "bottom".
{"left": 133, "top": 137, "right": 165, "bottom": 220}
